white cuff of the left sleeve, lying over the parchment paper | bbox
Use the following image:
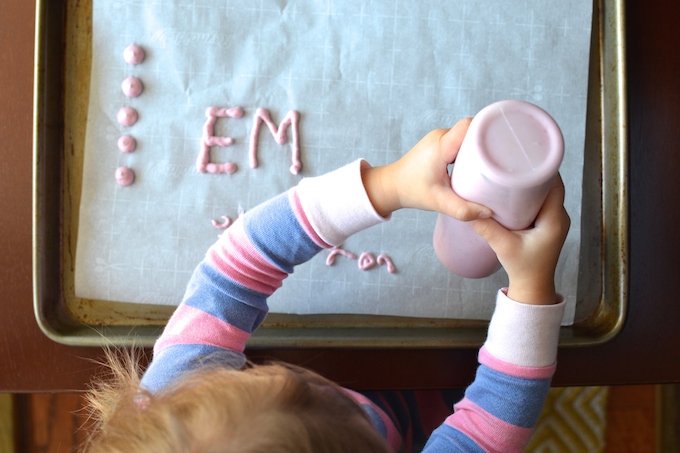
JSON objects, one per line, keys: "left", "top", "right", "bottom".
{"left": 297, "top": 159, "right": 389, "bottom": 246}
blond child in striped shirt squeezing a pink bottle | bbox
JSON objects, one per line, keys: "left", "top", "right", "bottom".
{"left": 90, "top": 119, "right": 569, "bottom": 452}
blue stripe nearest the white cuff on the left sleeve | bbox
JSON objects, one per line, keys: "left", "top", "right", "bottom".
{"left": 243, "top": 193, "right": 321, "bottom": 274}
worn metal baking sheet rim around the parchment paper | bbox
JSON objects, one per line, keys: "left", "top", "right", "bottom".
{"left": 33, "top": 0, "right": 628, "bottom": 348}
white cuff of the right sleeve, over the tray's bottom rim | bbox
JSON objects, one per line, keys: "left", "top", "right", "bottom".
{"left": 484, "top": 290, "right": 565, "bottom": 367}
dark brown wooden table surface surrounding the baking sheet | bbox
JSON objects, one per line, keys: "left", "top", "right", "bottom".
{"left": 0, "top": 0, "right": 680, "bottom": 392}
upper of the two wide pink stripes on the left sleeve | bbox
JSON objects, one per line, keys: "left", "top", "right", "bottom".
{"left": 206, "top": 220, "right": 288, "bottom": 296}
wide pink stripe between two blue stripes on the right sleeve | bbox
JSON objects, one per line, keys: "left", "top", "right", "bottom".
{"left": 444, "top": 398, "right": 533, "bottom": 453}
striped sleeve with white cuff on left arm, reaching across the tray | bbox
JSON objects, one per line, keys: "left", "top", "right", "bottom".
{"left": 142, "top": 160, "right": 387, "bottom": 392}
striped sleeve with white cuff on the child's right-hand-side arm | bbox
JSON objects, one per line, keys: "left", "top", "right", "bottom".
{"left": 424, "top": 290, "right": 565, "bottom": 453}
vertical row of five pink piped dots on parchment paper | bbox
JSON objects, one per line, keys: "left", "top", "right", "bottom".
{"left": 116, "top": 44, "right": 145, "bottom": 186}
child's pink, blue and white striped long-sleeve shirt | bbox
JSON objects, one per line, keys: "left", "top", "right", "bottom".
{"left": 142, "top": 160, "right": 564, "bottom": 452}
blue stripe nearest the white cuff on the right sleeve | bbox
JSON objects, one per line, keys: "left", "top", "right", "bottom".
{"left": 465, "top": 365, "right": 550, "bottom": 428}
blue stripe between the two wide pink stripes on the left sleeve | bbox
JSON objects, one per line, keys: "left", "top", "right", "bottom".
{"left": 183, "top": 261, "right": 268, "bottom": 333}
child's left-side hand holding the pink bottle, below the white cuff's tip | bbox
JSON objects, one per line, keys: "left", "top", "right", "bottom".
{"left": 362, "top": 118, "right": 491, "bottom": 220}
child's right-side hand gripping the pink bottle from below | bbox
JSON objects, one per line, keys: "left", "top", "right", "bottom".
{"left": 472, "top": 175, "right": 571, "bottom": 304}
